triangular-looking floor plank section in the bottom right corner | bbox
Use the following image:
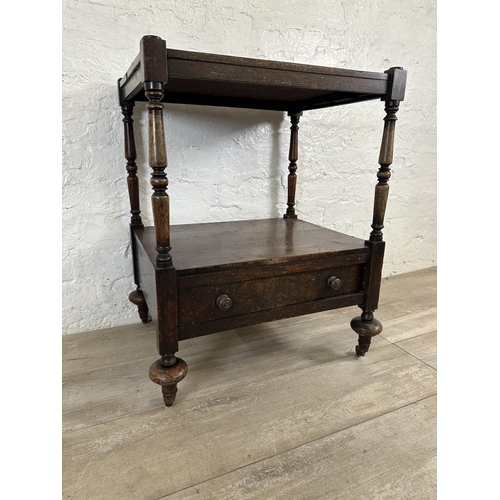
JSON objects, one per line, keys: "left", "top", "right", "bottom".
{"left": 162, "top": 396, "right": 437, "bottom": 500}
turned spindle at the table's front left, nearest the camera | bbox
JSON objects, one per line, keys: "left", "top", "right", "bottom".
{"left": 144, "top": 82, "right": 172, "bottom": 267}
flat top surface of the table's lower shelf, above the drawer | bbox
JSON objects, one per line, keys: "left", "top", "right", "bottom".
{"left": 136, "top": 219, "right": 368, "bottom": 275}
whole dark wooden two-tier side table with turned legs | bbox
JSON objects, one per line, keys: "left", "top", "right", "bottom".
{"left": 118, "top": 36, "right": 406, "bottom": 406}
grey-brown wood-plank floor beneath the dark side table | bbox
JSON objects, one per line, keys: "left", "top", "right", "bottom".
{"left": 63, "top": 268, "right": 437, "bottom": 500}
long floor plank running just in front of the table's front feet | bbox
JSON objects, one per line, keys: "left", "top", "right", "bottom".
{"left": 63, "top": 345, "right": 436, "bottom": 500}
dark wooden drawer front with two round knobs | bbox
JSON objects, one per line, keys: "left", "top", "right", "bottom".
{"left": 178, "top": 265, "right": 364, "bottom": 327}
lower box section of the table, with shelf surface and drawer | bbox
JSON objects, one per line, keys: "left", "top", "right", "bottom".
{"left": 134, "top": 219, "right": 371, "bottom": 340}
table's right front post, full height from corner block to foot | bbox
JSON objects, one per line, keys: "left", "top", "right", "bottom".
{"left": 351, "top": 68, "right": 406, "bottom": 356}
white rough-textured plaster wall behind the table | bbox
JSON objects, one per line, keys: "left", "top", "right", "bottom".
{"left": 62, "top": 0, "right": 436, "bottom": 333}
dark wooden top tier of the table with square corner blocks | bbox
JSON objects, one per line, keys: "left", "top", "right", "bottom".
{"left": 118, "top": 36, "right": 406, "bottom": 113}
